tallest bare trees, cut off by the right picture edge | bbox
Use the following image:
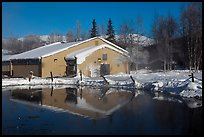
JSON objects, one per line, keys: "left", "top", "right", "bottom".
{"left": 180, "top": 3, "right": 202, "bottom": 70}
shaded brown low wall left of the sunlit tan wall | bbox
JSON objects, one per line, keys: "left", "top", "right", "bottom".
{"left": 12, "top": 65, "right": 41, "bottom": 77}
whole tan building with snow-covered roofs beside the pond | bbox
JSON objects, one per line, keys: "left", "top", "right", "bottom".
{"left": 10, "top": 37, "right": 129, "bottom": 77}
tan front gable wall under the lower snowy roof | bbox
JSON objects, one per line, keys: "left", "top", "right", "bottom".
{"left": 78, "top": 48, "right": 128, "bottom": 77}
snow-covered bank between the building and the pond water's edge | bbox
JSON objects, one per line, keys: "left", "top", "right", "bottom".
{"left": 2, "top": 70, "right": 202, "bottom": 99}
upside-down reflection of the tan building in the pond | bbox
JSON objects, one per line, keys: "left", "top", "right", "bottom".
{"left": 11, "top": 87, "right": 135, "bottom": 119}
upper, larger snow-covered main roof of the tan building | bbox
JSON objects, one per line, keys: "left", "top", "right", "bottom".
{"left": 10, "top": 37, "right": 128, "bottom": 59}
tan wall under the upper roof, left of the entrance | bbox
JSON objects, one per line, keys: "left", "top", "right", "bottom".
{"left": 42, "top": 38, "right": 112, "bottom": 77}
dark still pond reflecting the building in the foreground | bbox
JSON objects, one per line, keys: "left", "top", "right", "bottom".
{"left": 2, "top": 86, "right": 202, "bottom": 135}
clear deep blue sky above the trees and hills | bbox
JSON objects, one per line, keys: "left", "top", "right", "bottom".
{"left": 2, "top": 2, "right": 189, "bottom": 38}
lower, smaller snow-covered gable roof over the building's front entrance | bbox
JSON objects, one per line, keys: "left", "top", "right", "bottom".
{"left": 65, "top": 44, "right": 126, "bottom": 64}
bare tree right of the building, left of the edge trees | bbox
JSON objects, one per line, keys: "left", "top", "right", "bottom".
{"left": 152, "top": 15, "right": 177, "bottom": 71}
